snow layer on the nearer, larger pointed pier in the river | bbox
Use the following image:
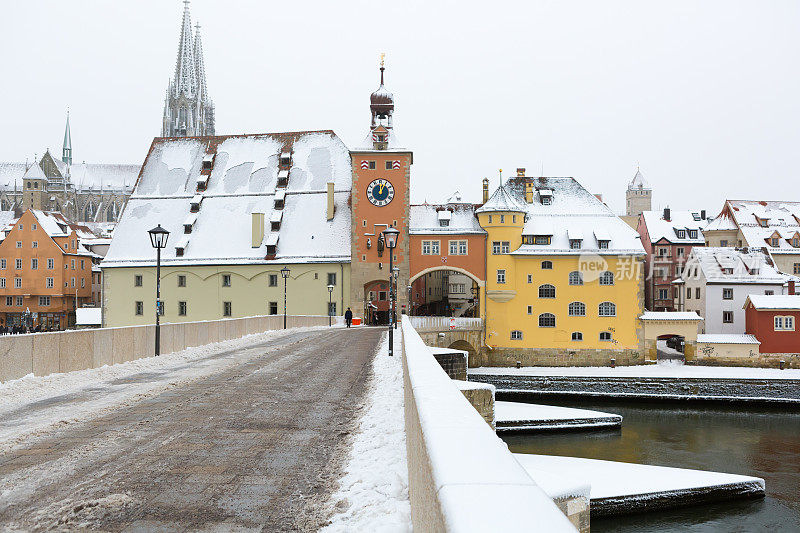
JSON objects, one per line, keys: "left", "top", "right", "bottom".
{"left": 514, "top": 453, "right": 764, "bottom": 500}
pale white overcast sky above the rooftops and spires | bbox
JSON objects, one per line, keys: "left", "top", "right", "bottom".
{"left": 0, "top": 0, "right": 800, "bottom": 213}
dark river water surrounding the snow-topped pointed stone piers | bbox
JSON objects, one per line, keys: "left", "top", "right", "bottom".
{"left": 503, "top": 401, "right": 800, "bottom": 533}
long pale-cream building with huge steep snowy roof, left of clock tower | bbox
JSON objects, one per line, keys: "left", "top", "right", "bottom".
{"left": 101, "top": 131, "right": 352, "bottom": 326}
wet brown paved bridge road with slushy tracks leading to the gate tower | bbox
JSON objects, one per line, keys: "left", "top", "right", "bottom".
{"left": 0, "top": 328, "right": 383, "bottom": 532}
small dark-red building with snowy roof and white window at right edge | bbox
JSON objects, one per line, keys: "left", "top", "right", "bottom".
{"left": 744, "top": 287, "right": 800, "bottom": 353}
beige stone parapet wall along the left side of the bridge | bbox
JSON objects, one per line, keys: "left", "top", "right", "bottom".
{"left": 0, "top": 315, "right": 341, "bottom": 382}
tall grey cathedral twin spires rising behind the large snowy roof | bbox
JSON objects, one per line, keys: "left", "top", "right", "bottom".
{"left": 161, "top": 0, "right": 214, "bottom": 137}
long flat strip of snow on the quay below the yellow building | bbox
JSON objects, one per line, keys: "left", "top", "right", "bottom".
{"left": 469, "top": 361, "right": 800, "bottom": 379}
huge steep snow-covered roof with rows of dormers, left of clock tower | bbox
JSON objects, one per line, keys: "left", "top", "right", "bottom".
{"left": 103, "top": 131, "right": 352, "bottom": 267}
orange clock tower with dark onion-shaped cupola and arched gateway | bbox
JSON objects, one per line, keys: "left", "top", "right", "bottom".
{"left": 350, "top": 56, "right": 413, "bottom": 323}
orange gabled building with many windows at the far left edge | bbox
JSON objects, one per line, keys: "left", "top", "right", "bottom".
{"left": 0, "top": 209, "right": 100, "bottom": 331}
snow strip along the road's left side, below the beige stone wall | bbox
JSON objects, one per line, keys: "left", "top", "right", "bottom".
{"left": 0, "top": 326, "right": 327, "bottom": 453}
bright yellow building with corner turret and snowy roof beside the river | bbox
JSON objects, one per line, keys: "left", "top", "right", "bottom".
{"left": 477, "top": 169, "right": 645, "bottom": 365}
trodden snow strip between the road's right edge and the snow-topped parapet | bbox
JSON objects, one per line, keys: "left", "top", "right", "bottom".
{"left": 322, "top": 330, "right": 411, "bottom": 533}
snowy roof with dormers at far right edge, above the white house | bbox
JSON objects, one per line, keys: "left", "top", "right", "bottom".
{"left": 720, "top": 200, "right": 800, "bottom": 254}
